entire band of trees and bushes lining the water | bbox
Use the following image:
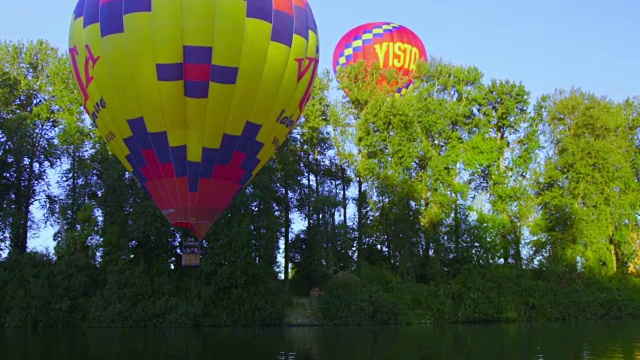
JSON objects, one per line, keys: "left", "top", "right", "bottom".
{"left": 0, "top": 40, "right": 640, "bottom": 328}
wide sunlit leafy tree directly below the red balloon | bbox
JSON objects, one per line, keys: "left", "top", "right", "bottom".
{"left": 355, "top": 61, "right": 482, "bottom": 276}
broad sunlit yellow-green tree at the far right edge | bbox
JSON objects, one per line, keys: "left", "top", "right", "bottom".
{"left": 539, "top": 89, "right": 640, "bottom": 274}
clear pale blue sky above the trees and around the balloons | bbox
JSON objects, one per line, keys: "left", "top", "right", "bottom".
{"left": 0, "top": 0, "right": 640, "bottom": 253}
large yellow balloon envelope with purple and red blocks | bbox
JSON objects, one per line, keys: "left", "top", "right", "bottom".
{"left": 69, "top": 0, "right": 319, "bottom": 262}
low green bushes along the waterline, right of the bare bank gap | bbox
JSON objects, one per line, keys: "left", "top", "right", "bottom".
{"left": 285, "top": 268, "right": 640, "bottom": 326}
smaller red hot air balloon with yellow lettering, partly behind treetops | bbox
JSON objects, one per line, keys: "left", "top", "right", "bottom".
{"left": 333, "top": 22, "right": 427, "bottom": 94}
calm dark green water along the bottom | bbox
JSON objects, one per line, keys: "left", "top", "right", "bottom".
{"left": 0, "top": 322, "right": 640, "bottom": 360}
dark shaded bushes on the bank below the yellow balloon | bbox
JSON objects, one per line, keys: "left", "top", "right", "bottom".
{"left": 0, "top": 253, "right": 287, "bottom": 328}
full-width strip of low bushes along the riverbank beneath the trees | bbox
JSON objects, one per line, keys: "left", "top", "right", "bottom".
{"left": 0, "top": 254, "right": 640, "bottom": 328}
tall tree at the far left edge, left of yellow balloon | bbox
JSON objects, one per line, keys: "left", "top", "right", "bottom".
{"left": 0, "top": 40, "right": 68, "bottom": 254}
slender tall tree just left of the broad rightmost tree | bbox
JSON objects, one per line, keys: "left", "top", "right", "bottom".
{"left": 464, "top": 79, "right": 539, "bottom": 267}
